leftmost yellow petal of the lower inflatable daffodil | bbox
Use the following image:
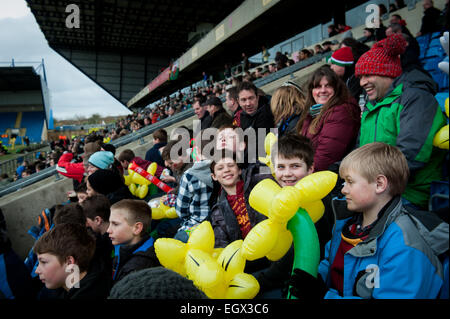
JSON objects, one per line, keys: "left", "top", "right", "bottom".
{"left": 155, "top": 238, "right": 187, "bottom": 273}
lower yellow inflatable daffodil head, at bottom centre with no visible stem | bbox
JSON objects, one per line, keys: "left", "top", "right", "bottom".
{"left": 155, "top": 221, "right": 259, "bottom": 299}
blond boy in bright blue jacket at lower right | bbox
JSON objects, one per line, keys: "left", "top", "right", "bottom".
{"left": 291, "top": 142, "right": 449, "bottom": 299}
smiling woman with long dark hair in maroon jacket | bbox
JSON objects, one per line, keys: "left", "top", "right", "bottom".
{"left": 298, "top": 65, "right": 361, "bottom": 172}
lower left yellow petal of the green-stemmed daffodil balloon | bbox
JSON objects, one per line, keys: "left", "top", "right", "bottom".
{"left": 241, "top": 219, "right": 281, "bottom": 260}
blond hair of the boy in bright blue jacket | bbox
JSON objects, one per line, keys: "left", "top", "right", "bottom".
{"left": 339, "top": 142, "right": 409, "bottom": 196}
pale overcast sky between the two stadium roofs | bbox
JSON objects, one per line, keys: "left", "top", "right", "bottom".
{"left": 0, "top": 0, "right": 132, "bottom": 119}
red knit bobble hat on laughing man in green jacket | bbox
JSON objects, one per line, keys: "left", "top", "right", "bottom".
{"left": 355, "top": 34, "right": 407, "bottom": 78}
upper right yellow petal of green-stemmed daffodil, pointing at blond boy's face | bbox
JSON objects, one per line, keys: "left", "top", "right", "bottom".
{"left": 295, "top": 171, "right": 338, "bottom": 204}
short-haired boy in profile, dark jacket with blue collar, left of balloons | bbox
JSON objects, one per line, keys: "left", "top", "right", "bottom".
{"left": 107, "top": 199, "right": 160, "bottom": 284}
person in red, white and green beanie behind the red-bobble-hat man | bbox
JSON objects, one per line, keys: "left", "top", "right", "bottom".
{"left": 329, "top": 46, "right": 364, "bottom": 101}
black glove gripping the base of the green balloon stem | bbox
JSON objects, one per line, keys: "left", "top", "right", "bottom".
{"left": 289, "top": 268, "right": 327, "bottom": 300}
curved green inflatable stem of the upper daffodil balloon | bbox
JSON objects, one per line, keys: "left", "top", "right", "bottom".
{"left": 287, "top": 208, "right": 320, "bottom": 299}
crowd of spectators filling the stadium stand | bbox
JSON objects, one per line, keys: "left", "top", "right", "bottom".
{"left": 0, "top": 0, "right": 449, "bottom": 300}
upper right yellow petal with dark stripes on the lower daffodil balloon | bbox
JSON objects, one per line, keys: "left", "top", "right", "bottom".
{"left": 217, "top": 239, "right": 245, "bottom": 281}
